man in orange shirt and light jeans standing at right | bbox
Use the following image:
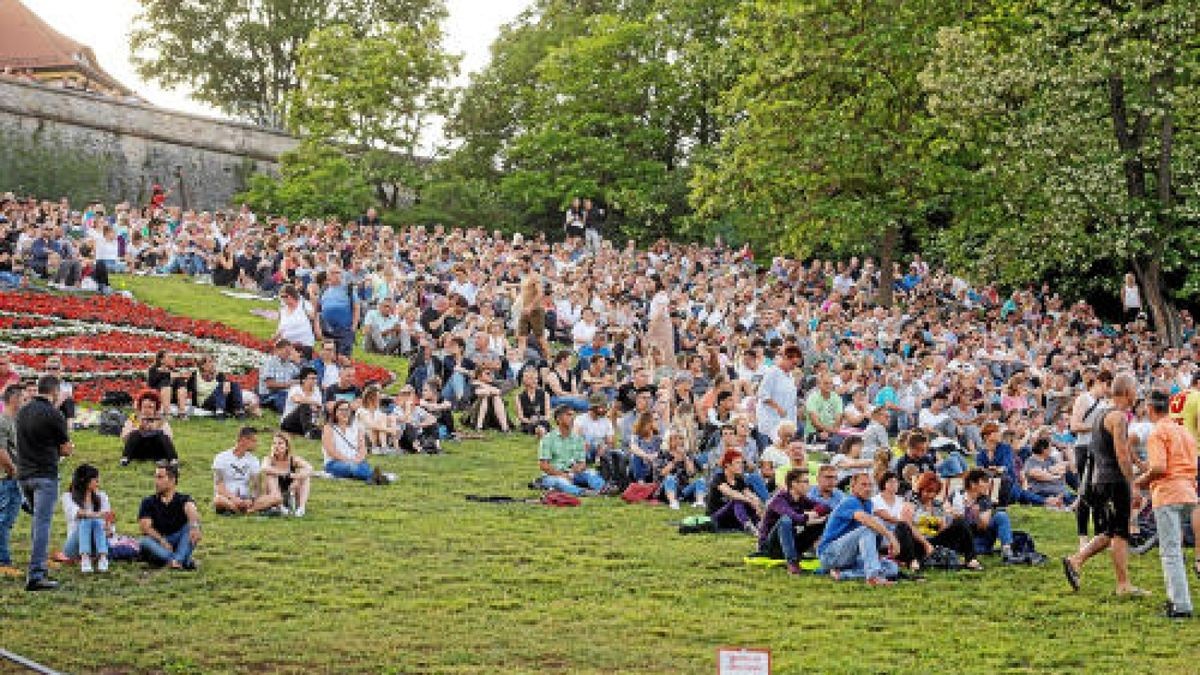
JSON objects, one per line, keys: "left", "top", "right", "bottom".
{"left": 1134, "top": 390, "right": 1196, "bottom": 619}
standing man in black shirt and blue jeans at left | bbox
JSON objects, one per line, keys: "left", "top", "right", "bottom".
{"left": 16, "top": 375, "right": 74, "bottom": 591}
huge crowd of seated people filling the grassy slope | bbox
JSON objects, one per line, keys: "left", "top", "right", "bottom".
{"left": 0, "top": 187, "right": 1200, "bottom": 613}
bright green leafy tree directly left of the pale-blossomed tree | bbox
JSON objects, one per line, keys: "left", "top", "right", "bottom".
{"left": 692, "top": 0, "right": 966, "bottom": 301}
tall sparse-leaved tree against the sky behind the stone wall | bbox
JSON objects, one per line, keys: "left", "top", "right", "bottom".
{"left": 130, "top": 0, "right": 444, "bottom": 127}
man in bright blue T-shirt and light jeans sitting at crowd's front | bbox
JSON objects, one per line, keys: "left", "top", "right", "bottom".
{"left": 817, "top": 473, "right": 900, "bottom": 586}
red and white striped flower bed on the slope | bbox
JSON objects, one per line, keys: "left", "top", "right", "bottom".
{"left": 0, "top": 292, "right": 395, "bottom": 401}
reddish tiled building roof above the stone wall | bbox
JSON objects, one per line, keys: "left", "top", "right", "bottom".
{"left": 0, "top": 0, "right": 132, "bottom": 95}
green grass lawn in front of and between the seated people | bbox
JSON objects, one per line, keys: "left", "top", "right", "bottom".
{"left": 0, "top": 279, "right": 1200, "bottom": 673}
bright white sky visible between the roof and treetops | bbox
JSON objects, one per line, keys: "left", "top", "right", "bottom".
{"left": 23, "top": 0, "right": 529, "bottom": 128}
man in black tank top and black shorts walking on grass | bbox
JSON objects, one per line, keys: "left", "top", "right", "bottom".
{"left": 1062, "top": 372, "right": 1146, "bottom": 596}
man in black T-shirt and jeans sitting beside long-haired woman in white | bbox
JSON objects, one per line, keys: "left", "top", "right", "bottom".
{"left": 138, "top": 462, "right": 202, "bottom": 569}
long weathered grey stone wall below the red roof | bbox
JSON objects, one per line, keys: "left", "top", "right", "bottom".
{"left": 0, "top": 79, "right": 299, "bottom": 209}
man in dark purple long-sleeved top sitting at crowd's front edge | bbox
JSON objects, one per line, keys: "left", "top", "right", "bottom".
{"left": 758, "top": 468, "right": 829, "bottom": 574}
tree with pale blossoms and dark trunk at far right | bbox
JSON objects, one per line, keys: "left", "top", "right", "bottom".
{"left": 923, "top": 0, "right": 1200, "bottom": 340}
